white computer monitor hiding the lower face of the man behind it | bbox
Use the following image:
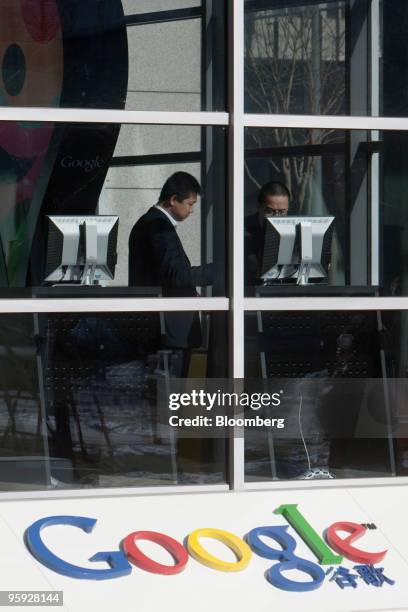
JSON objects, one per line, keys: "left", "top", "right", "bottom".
{"left": 260, "top": 217, "right": 334, "bottom": 285}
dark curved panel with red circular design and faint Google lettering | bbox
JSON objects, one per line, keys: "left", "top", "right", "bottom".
{"left": 0, "top": 0, "right": 128, "bottom": 287}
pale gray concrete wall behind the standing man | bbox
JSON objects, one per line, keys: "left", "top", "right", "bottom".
{"left": 99, "top": 0, "right": 201, "bottom": 286}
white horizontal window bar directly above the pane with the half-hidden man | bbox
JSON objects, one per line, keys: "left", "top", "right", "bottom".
{"left": 244, "top": 114, "right": 408, "bottom": 131}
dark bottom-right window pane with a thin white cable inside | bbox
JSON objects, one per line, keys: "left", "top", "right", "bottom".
{"left": 245, "top": 311, "right": 408, "bottom": 481}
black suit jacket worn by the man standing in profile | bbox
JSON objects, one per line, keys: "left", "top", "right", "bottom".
{"left": 129, "top": 206, "right": 213, "bottom": 348}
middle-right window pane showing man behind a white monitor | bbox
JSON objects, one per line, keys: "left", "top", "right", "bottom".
{"left": 244, "top": 128, "right": 408, "bottom": 296}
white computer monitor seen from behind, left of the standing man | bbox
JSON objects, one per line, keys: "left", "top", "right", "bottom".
{"left": 45, "top": 215, "right": 119, "bottom": 285}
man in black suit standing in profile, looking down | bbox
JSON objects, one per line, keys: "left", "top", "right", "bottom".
{"left": 129, "top": 172, "right": 213, "bottom": 378}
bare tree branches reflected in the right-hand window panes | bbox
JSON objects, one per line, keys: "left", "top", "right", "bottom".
{"left": 245, "top": 3, "right": 345, "bottom": 212}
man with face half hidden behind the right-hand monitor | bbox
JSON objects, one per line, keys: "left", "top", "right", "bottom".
{"left": 245, "top": 181, "right": 290, "bottom": 286}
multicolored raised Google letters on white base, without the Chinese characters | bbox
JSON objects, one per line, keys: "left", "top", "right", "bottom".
{"left": 25, "top": 504, "right": 387, "bottom": 591}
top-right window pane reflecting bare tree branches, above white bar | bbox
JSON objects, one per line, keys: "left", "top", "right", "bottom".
{"left": 245, "top": 0, "right": 408, "bottom": 117}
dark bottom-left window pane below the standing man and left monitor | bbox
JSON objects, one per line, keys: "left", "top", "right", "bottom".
{"left": 0, "top": 312, "right": 228, "bottom": 490}
